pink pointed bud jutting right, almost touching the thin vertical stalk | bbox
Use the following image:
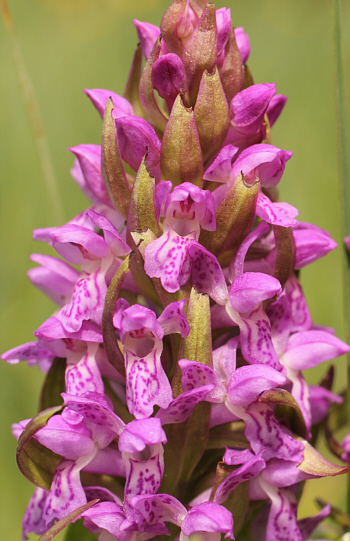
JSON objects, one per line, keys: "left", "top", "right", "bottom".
{"left": 293, "top": 223, "right": 337, "bottom": 269}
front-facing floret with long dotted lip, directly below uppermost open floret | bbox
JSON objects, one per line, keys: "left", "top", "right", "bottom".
{"left": 113, "top": 300, "right": 189, "bottom": 419}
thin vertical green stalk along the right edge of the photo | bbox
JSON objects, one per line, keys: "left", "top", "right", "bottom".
{"left": 331, "top": 0, "right": 350, "bottom": 513}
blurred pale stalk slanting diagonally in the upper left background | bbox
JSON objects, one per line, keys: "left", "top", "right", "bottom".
{"left": 0, "top": 0, "right": 64, "bottom": 225}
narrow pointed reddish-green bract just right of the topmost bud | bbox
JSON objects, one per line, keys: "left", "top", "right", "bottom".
{"left": 182, "top": 4, "right": 217, "bottom": 105}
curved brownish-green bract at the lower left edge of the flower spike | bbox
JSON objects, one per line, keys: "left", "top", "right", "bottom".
{"left": 16, "top": 406, "right": 63, "bottom": 490}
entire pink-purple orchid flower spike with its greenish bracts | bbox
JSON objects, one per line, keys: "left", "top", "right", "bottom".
{"left": 2, "top": 0, "right": 350, "bottom": 541}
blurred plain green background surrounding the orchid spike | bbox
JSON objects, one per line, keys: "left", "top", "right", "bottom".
{"left": 0, "top": 0, "right": 350, "bottom": 541}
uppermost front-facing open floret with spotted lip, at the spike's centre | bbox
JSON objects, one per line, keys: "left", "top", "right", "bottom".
{"left": 145, "top": 182, "right": 216, "bottom": 292}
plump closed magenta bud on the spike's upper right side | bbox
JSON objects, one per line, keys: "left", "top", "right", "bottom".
{"left": 230, "top": 83, "right": 276, "bottom": 135}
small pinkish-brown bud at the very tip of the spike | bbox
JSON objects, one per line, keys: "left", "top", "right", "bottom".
{"left": 160, "top": 0, "right": 199, "bottom": 57}
